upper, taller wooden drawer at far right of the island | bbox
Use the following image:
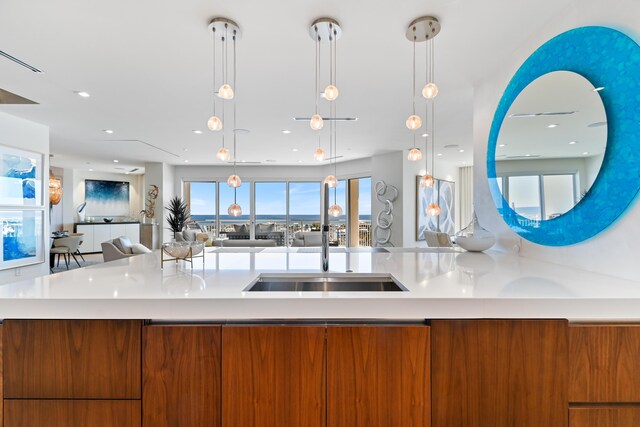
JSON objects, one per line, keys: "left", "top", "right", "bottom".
{"left": 569, "top": 325, "right": 640, "bottom": 403}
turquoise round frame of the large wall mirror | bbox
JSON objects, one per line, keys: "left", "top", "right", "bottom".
{"left": 487, "top": 27, "right": 640, "bottom": 246}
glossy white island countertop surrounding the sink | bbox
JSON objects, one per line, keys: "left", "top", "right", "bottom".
{"left": 0, "top": 248, "right": 640, "bottom": 321}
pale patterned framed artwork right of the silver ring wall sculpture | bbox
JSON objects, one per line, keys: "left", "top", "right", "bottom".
{"left": 416, "top": 176, "right": 456, "bottom": 241}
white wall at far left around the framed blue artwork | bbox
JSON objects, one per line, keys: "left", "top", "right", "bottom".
{"left": 0, "top": 113, "right": 49, "bottom": 284}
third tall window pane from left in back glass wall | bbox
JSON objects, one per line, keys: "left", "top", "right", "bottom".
{"left": 254, "top": 182, "right": 287, "bottom": 246}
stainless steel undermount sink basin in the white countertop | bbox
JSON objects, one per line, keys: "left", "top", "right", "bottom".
{"left": 246, "top": 274, "right": 407, "bottom": 292}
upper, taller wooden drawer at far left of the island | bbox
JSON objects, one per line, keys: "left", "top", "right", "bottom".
{"left": 3, "top": 320, "right": 142, "bottom": 399}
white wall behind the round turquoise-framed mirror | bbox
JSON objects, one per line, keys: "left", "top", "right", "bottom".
{"left": 473, "top": 0, "right": 640, "bottom": 285}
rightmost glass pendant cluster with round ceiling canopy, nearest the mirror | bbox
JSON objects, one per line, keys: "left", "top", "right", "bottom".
{"left": 406, "top": 16, "right": 440, "bottom": 216}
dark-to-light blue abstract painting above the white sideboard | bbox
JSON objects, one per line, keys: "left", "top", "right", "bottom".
{"left": 84, "top": 179, "right": 131, "bottom": 217}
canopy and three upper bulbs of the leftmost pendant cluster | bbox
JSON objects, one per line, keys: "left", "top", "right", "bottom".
{"left": 207, "top": 18, "right": 240, "bottom": 162}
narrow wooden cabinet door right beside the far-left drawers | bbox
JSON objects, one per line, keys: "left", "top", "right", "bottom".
{"left": 142, "top": 325, "right": 221, "bottom": 427}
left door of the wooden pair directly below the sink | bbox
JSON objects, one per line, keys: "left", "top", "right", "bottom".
{"left": 222, "top": 325, "right": 326, "bottom": 427}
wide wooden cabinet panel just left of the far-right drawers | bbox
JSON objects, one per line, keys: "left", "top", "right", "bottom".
{"left": 431, "top": 320, "right": 569, "bottom": 427}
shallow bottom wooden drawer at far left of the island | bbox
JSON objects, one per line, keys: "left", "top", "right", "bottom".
{"left": 4, "top": 399, "right": 141, "bottom": 427}
